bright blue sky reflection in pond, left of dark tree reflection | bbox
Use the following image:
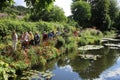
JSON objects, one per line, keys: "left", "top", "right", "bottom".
{"left": 52, "top": 64, "right": 82, "bottom": 80}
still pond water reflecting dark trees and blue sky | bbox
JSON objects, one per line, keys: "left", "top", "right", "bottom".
{"left": 25, "top": 47, "right": 120, "bottom": 80}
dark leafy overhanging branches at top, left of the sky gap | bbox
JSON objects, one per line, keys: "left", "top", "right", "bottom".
{"left": 24, "top": 0, "right": 55, "bottom": 21}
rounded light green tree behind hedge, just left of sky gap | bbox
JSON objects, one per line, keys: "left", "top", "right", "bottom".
{"left": 31, "top": 6, "right": 67, "bottom": 22}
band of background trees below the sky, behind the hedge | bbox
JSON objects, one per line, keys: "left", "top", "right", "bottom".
{"left": 2, "top": 0, "right": 120, "bottom": 31}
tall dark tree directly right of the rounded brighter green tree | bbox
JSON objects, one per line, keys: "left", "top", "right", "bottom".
{"left": 89, "top": 0, "right": 111, "bottom": 30}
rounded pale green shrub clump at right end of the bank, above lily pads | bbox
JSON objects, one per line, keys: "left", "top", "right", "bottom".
{"left": 78, "top": 29, "right": 103, "bottom": 45}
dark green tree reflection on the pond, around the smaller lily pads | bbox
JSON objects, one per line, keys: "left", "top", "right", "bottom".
{"left": 71, "top": 48, "right": 118, "bottom": 80}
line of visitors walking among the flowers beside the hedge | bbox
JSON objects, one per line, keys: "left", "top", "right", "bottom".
{"left": 12, "top": 30, "right": 61, "bottom": 50}
